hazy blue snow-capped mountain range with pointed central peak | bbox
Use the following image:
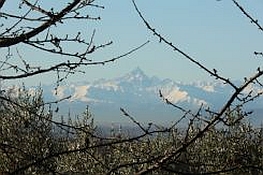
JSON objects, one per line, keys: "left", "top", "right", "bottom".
{"left": 44, "top": 68, "right": 263, "bottom": 122}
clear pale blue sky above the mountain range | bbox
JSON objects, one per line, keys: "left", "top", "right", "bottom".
{"left": 4, "top": 0, "right": 263, "bottom": 83}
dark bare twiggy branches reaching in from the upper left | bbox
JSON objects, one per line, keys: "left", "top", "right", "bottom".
{"left": 0, "top": 0, "right": 148, "bottom": 81}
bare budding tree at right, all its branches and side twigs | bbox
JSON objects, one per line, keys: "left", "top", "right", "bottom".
{"left": 124, "top": 0, "right": 263, "bottom": 174}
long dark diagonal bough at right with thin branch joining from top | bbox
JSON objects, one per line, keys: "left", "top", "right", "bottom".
{"left": 132, "top": 0, "right": 263, "bottom": 175}
